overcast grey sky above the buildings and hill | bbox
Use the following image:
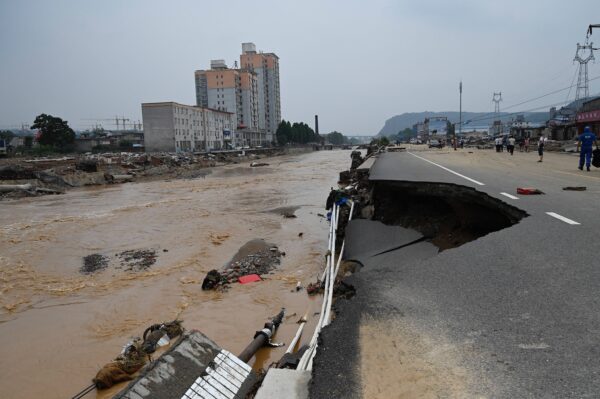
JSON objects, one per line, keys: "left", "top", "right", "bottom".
{"left": 0, "top": 0, "right": 600, "bottom": 135}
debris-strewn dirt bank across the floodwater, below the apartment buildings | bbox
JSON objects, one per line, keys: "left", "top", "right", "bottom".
{"left": 0, "top": 148, "right": 310, "bottom": 199}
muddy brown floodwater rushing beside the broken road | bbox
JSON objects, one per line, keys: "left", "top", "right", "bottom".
{"left": 0, "top": 151, "right": 350, "bottom": 398}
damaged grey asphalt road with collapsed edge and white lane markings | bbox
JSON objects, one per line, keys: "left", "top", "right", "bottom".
{"left": 310, "top": 151, "right": 600, "bottom": 398}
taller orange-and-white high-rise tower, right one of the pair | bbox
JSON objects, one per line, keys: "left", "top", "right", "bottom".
{"left": 240, "top": 43, "right": 281, "bottom": 140}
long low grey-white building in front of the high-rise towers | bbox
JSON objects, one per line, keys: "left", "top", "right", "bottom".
{"left": 142, "top": 102, "right": 236, "bottom": 152}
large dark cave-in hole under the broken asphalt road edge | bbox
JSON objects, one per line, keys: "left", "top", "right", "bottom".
{"left": 372, "top": 181, "right": 528, "bottom": 250}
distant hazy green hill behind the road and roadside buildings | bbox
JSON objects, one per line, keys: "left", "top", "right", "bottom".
{"left": 377, "top": 111, "right": 549, "bottom": 136}
